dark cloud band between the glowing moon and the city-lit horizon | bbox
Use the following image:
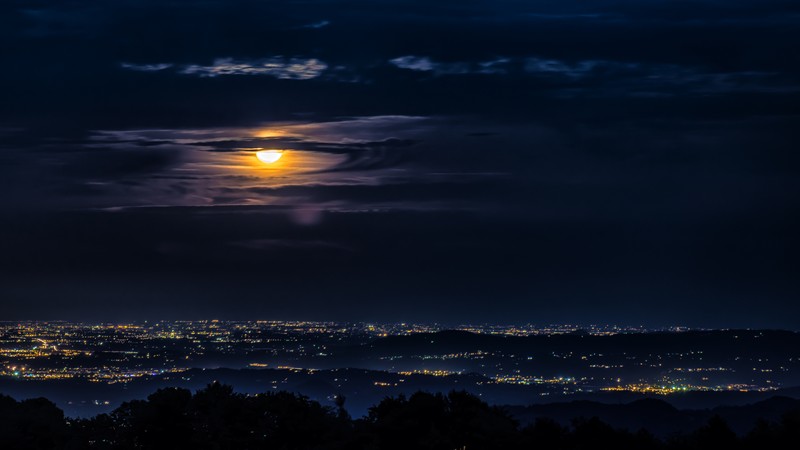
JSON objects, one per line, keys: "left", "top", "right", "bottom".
{"left": 3, "top": 207, "right": 797, "bottom": 326}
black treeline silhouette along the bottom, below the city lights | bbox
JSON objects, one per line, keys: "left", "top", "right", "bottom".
{"left": 0, "top": 383, "right": 800, "bottom": 450}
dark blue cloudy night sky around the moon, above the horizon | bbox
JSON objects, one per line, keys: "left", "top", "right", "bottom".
{"left": 0, "top": 0, "right": 800, "bottom": 329}
